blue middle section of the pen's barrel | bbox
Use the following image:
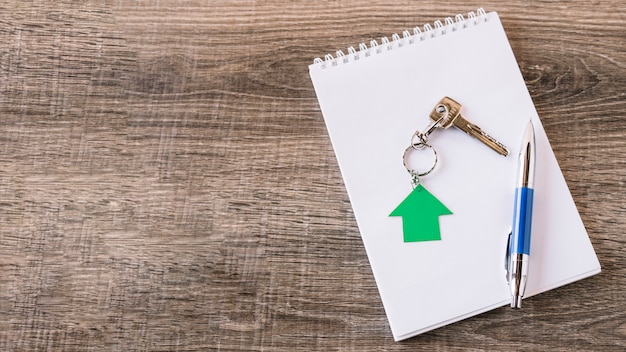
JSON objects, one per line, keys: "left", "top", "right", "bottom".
{"left": 511, "top": 187, "right": 534, "bottom": 255}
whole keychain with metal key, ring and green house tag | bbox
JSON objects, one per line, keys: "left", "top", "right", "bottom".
{"left": 389, "top": 97, "right": 509, "bottom": 242}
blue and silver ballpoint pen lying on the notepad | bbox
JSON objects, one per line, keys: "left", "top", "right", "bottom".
{"left": 507, "top": 121, "right": 535, "bottom": 308}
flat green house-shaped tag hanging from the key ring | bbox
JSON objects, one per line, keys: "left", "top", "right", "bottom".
{"left": 389, "top": 184, "right": 452, "bottom": 242}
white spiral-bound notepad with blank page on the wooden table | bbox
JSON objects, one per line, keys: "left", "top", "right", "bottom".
{"left": 309, "top": 9, "right": 600, "bottom": 340}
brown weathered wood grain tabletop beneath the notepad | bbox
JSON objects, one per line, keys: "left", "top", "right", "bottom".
{"left": 0, "top": 0, "right": 626, "bottom": 351}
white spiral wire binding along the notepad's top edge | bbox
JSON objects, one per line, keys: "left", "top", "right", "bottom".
{"left": 313, "top": 8, "right": 487, "bottom": 69}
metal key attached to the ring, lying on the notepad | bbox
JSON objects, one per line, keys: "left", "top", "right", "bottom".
{"left": 430, "top": 97, "right": 509, "bottom": 156}
